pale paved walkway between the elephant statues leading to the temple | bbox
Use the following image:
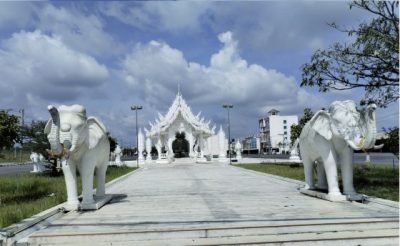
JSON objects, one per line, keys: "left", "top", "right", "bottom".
{"left": 18, "top": 160, "right": 399, "bottom": 245}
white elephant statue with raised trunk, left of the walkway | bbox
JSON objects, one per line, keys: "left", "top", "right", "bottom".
{"left": 44, "top": 105, "right": 110, "bottom": 210}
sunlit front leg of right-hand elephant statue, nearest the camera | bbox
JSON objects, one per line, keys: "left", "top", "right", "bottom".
{"left": 323, "top": 151, "right": 346, "bottom": 201}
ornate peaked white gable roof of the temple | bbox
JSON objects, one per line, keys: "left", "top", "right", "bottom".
{"left": 148, "top": 90, "right": 215, "bottom": 137}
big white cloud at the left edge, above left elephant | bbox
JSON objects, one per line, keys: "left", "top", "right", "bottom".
{"left": 0, "top": 31, "right": 109, "bottom": 103}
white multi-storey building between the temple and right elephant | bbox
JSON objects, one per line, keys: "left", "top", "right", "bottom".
{"left": 259, "top": 109, "right": 299, "bottom": 154}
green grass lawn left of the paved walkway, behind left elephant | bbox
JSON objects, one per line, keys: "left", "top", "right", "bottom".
{"left": 0, "top": 166, "right": 136, "bottom": 228}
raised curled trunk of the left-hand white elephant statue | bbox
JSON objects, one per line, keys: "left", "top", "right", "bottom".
{"left": 47, "top": 105, "right": 63, "bottom": 156}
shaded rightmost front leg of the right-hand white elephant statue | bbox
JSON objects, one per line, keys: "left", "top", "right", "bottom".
{"left": 340, "top": 148, "right": 357, "bottom": 195}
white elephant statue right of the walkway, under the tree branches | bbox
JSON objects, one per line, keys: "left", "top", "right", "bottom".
{"left": 299, "top": 100, "right": 383, "bottom": 201}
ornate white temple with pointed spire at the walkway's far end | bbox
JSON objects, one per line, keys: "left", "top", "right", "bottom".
{"left": 145, "top": 91, "right": 227, "bottom": 163}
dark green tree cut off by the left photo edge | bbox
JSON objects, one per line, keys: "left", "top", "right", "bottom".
{"left": 0, "top": 110, "right": 20, "bottom": 152}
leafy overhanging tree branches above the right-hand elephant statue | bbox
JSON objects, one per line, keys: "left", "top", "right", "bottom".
{"left": 301, "top": 0, "right": 399, "bottom": 107}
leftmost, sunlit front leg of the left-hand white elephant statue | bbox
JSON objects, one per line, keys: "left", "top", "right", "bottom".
{"left": 61, "top": 160, "right": 79, "bottom": 210}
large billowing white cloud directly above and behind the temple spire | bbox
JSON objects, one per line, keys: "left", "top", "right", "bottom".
{"left": 121, "top": 32, "right": 324, "bottom": 119}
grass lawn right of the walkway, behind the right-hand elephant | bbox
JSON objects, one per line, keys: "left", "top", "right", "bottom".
{"left": 236, "top": 163, "right": 399, "bottom": 201}
